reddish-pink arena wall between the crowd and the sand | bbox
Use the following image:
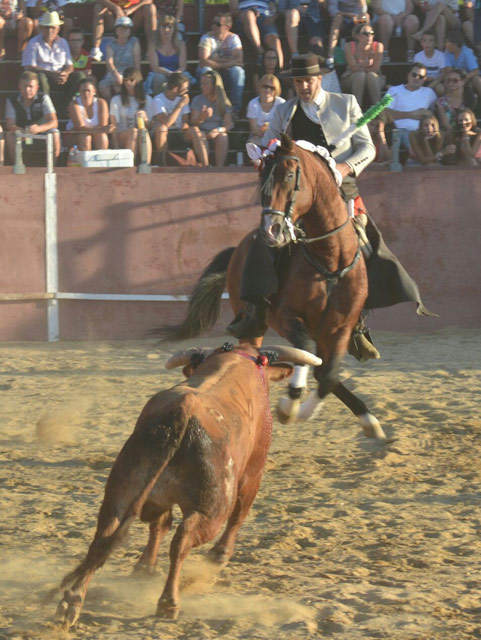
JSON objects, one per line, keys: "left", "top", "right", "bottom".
{"left": 0, "top": 167, "right": 481, "bottom": 341}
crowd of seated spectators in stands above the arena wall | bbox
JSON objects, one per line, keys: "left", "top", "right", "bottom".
{"left": 0, "top": 0, "right": 481, "bottom": 166}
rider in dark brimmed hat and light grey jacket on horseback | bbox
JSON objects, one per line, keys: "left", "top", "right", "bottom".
{"left": 226, "top": 53, "right": 428, "bottom": 361}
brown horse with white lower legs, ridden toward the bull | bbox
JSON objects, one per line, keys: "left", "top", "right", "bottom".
{"left": 156, "top": 134, "right": 385, "bottom": 438}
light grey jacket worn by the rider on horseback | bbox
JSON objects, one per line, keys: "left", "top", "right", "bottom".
{"left": 262, "top": 89, "right": 376, "bottom": 176}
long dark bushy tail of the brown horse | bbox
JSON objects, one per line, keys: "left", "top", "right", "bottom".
{"left": 150, "top": 247, "right": 235, "bottom": 342}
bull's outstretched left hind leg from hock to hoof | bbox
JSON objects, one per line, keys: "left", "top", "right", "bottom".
{"left": 56, "top": 509, "right": 134, "bottom": 629}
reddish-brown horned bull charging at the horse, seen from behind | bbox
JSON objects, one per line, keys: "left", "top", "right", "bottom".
{"left": 57, "top": 345, "right": 320, "bottom": 628}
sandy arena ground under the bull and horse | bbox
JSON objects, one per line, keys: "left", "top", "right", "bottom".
{"left": 0, "top": 331, "right": 481, "bottom": 640}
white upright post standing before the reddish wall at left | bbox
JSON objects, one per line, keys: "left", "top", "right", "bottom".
{"left": 45, "top": 134, "right": 60, "bottom": 342}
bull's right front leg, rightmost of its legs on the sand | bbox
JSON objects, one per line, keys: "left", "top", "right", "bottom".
{"left": 209, "top": 472, "right": 262, "bottom": 567}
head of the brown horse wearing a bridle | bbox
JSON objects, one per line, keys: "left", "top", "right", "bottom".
{"left": 259, "top": 134, "right": 308, "bottom": 247}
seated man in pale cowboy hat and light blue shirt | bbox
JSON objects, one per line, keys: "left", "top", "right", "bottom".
{"left": 22, "top": 11, "right": 85, "bottom": 113}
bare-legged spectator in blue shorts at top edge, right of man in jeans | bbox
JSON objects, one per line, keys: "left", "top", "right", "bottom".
{"left": 229, "top": 0, "right": 284, "bottom": 69}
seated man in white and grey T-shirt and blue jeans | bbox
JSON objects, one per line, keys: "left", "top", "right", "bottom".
{"left": 199, "top": 13, "right": 245, "bottom": 115}
